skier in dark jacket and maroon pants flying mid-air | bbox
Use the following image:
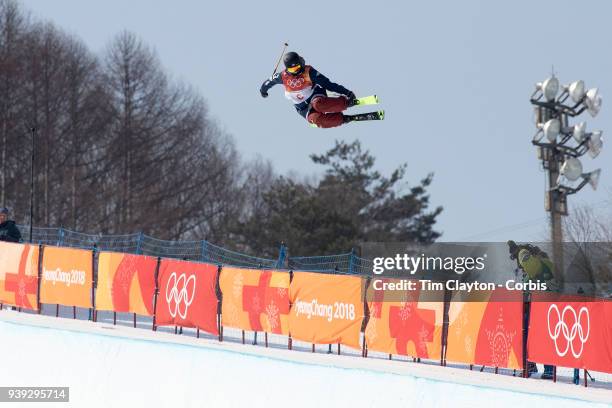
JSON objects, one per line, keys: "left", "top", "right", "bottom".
{"left": 259, "top": 52, "right": 384, "bottom": 128}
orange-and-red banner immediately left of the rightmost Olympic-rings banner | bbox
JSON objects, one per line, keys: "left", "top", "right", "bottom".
{"left": 446, "top": 290, "right": 523, "bottom": 369}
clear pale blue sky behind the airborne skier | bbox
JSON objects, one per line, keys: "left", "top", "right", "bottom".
{"left": 22, "top": 0, "right": 612, "bottom": 241}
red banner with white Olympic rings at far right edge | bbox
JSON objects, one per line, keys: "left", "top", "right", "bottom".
{"left": 527, "top": 293, "right": 612, "bottom": 373}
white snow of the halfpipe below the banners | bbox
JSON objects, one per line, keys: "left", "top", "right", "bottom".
{"left": 0, "top": 310, "right": 612, "bottom": 408}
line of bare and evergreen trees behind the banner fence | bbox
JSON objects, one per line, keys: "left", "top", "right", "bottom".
{"left": 0, "top": 0, "right": 441, "bottom": 255}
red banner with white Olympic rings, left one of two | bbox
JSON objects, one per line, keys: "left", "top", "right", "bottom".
{"left": 155, "top": 259, "right": 219, "bottom": 334}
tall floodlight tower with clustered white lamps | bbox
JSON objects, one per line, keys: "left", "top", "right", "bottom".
{"left": 530, "top": 74, "right": 603, "bottom": 287}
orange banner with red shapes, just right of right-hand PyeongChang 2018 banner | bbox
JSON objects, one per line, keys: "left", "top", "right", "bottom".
{"left": 365, "top": 279, "right": 444, "bottom": 359}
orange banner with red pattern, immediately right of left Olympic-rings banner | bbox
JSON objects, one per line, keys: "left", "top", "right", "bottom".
{"left": 219, "top": 267, "right": 289, "bottom": 335}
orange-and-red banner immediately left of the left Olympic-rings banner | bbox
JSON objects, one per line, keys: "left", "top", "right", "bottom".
{"left": 96, "top": 252, "right": 157, "bottom": 316}
